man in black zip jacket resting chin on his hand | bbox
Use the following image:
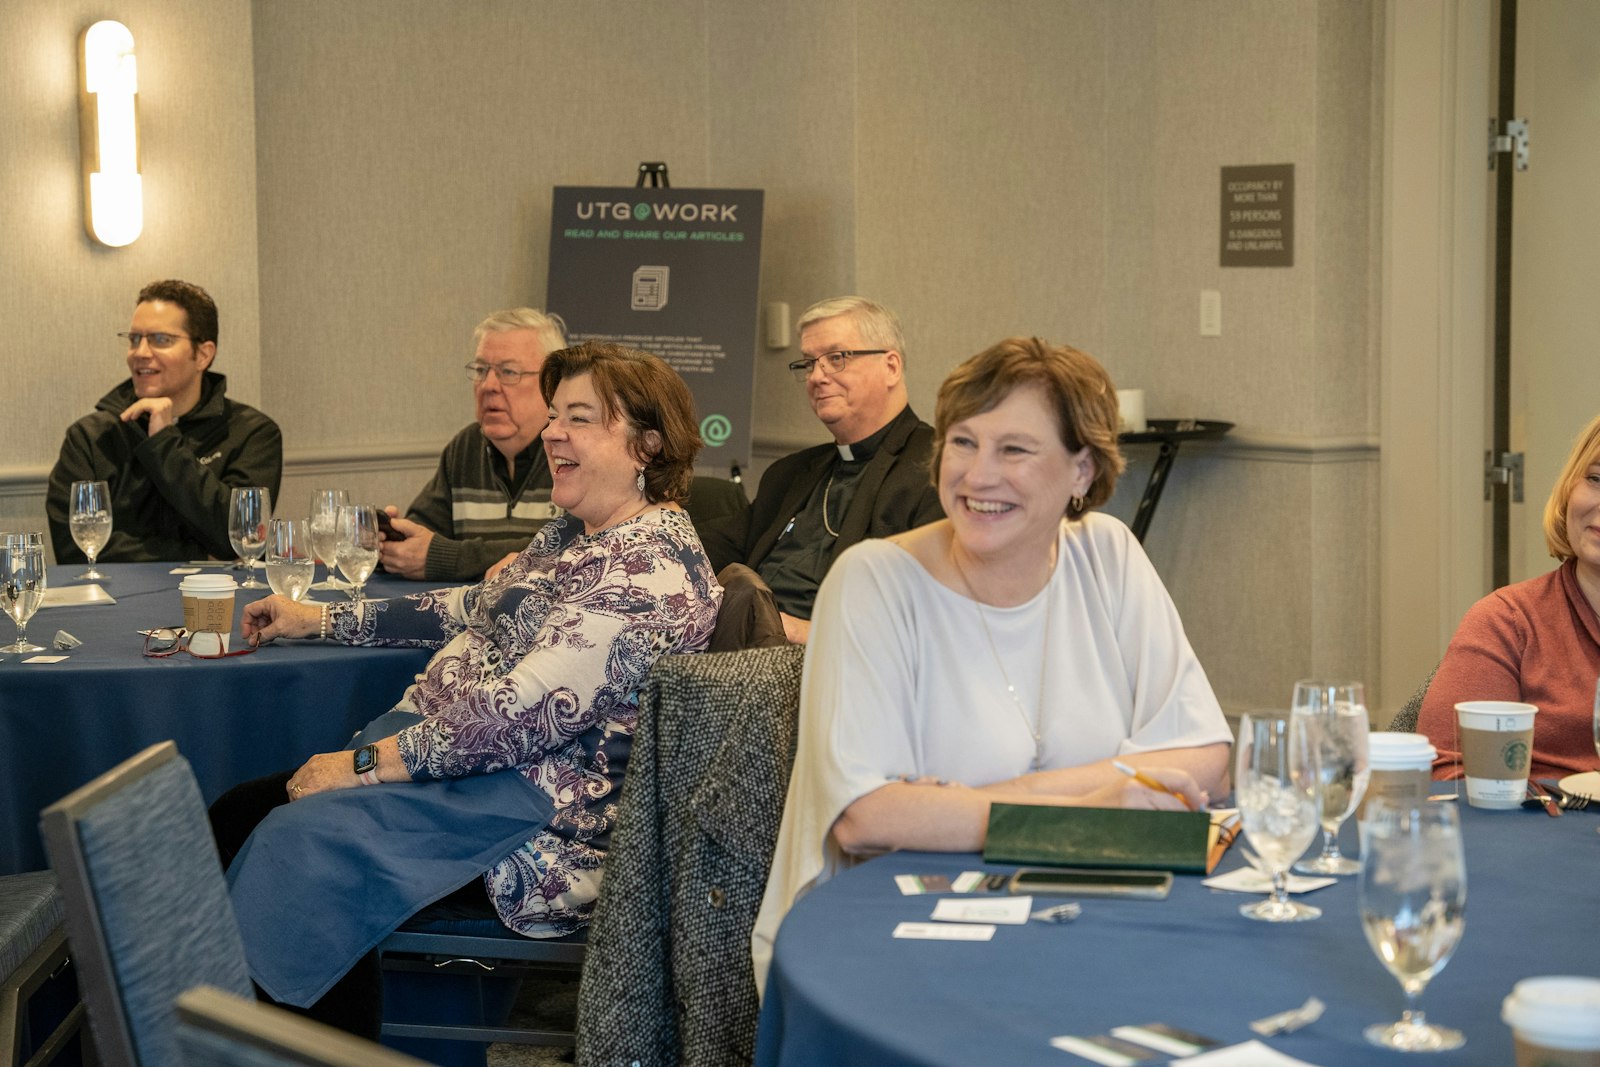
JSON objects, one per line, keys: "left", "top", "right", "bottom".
{"left": 45, "top": 280, "right": 283, "bottom": 563}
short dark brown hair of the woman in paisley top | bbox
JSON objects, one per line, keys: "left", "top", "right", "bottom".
{"left": 539, "top": 341, "right": 701, "bottom": 504}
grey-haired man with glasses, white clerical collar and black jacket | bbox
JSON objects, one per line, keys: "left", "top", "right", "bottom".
{"left": 701, "top": 296, "right": 944, "bottom": 643}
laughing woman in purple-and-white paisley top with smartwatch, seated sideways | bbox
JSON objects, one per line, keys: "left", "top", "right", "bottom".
{"left": 213, "top": 342, "right": 722, "bottom": 1035}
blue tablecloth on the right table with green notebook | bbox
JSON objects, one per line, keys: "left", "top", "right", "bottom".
{"left": 755, "top": 801, "right": 1600, "bottom": 1067}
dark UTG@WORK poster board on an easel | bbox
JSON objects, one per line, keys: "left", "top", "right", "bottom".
{"left": 544, "top": 186, "right": 762, "bottom": 474}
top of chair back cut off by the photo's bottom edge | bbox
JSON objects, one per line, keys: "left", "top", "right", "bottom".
{"left": 178, "top": 985, "right": 422, "bottom": 1067}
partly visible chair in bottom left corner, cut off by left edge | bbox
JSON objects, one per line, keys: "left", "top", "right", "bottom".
{"left": 0, "top": 870, "right": 83, "bottom": 1067}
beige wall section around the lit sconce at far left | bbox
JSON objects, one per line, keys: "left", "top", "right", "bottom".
{"left": 0, "top": 0, "right": 261, "bottom": 530}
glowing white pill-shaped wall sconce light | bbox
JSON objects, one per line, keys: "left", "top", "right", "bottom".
{"left": 78, "top": 19, "right": 144, "bottom": 248}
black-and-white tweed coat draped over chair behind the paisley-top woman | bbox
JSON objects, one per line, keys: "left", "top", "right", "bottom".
{"left": 578, "top": 645, "right": 805, "bottom": 1067}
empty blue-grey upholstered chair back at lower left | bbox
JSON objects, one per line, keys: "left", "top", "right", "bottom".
{"left": 40, "top": 741, "right": 254, "bottom": 1067}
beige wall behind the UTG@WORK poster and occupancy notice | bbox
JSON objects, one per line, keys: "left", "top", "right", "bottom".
{"left": 0, "top": 0, "right": 1403, "bottom": 707}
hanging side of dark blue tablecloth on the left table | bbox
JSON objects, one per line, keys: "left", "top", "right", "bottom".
{"left": 0, "top": 563, "right": 429, "bottom": 873}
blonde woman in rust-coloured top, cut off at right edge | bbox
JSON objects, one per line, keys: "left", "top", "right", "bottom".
{"left": 1418, "top": 418, "right": 1600, "bottom": 777}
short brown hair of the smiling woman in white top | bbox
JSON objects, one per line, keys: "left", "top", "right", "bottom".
{"left": 933, "top": 338, "right": 1123, "bottom": 518}
